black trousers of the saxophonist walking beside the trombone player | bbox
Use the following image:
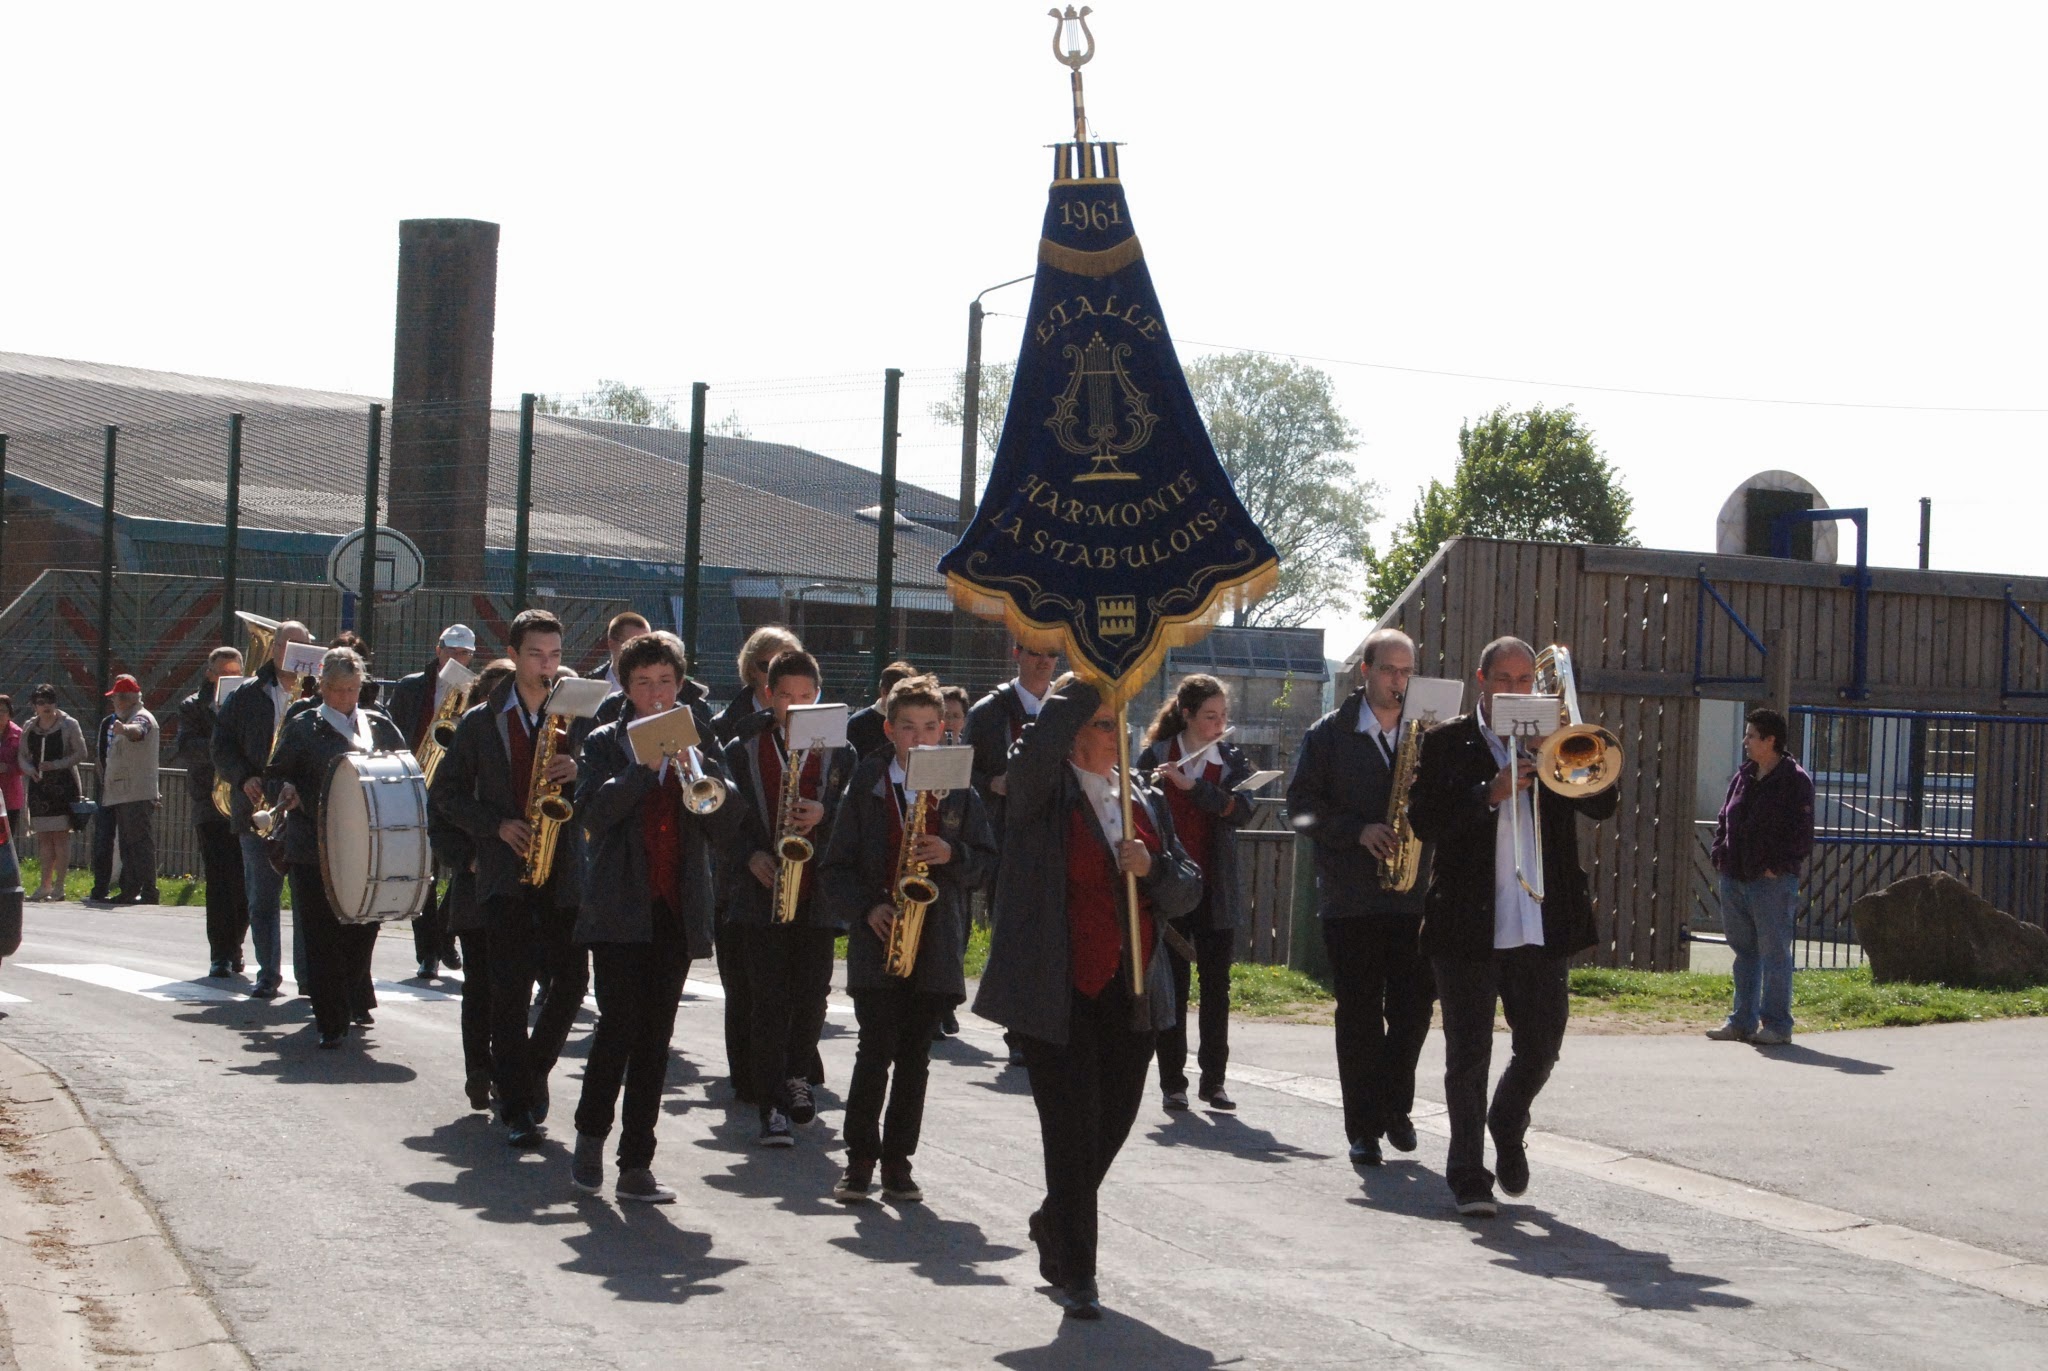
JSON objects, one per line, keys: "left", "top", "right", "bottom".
{"left": 1323, "top": 914, "right": 1433, "bottom": 1141}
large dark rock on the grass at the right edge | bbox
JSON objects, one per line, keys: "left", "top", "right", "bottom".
{"left": 1849, "top": 871, "right": 2048, "bottom": 990}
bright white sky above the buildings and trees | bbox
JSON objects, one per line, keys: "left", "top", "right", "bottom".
{"left": 0, "top": 0, "right": 2048, "bottom": 656}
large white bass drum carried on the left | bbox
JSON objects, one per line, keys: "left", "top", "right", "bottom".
{"left": 319, "top": 752, "right": 434, "bottom": 924}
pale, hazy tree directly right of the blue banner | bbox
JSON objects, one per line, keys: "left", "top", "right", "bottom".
{"left": 1188, "top": 352, "right": 1380, "bottom": 627}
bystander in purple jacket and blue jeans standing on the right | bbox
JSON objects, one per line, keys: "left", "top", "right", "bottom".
{"left": 1708, "top": 709, "right": 1812, "bottom": 1047}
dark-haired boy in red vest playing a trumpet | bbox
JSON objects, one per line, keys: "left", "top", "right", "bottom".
{"left": 569, "top": 633, "right": 739, "bottom": 1205}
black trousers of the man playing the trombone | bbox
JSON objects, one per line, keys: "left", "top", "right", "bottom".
{"left": 1434, "top": 947, "right": 1571, "bottom": 1195}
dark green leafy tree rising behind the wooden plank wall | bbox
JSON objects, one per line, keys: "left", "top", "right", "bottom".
{"left": 1366, "top": 406, "right": 1636, "bottom": 615}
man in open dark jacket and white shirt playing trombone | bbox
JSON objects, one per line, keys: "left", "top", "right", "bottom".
{"left": 1409, "top": 637, "right": 1618, "bottom": 1217}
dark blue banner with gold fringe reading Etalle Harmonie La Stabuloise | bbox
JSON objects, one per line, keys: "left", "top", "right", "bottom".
{"left": 938, "top": 143, "right": 1280, "bottom": 703}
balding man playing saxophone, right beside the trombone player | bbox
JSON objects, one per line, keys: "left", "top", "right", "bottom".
{"left": 1286, "top": 629, "right": 1436, "bottom": 1166}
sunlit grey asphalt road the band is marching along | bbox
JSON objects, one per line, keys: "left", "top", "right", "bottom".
{"left": 0, "top": 906, "right": 2048, "bottom": 1371}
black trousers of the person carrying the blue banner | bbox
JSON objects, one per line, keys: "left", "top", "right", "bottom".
{"left": 1018, "top": 971, "right": 1159, "bottom": 1285}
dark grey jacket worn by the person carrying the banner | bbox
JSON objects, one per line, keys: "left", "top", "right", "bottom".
{"left": 975, "top": 680, "right": 1202, "bottom": 1045}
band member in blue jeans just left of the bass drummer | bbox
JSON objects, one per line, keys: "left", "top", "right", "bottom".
{"left": 213, "top": 619, "right": 313, "bottom": 1000}
